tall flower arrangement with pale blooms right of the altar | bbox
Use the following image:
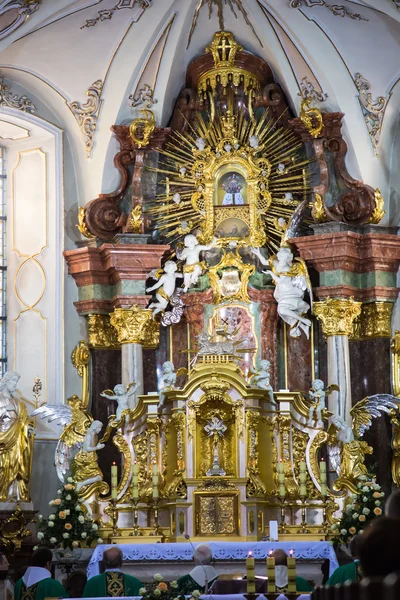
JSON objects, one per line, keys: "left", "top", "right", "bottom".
{"left": 332, "top": 475, "right": 385, "bottom": 546}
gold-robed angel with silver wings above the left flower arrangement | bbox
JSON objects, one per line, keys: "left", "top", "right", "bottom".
{"left": 32, "top": 396, "right": 104, "bottom": 490}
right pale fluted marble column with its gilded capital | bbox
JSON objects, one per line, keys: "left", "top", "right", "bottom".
{"left": 314, "top": 298, "right": 361, "bottom": 425}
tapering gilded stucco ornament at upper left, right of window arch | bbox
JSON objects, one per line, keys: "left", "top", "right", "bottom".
{"left": 69, "top": 79, "right": 103, "bottom": 158}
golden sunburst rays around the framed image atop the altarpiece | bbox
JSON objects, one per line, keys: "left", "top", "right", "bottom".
{"left": 147, "top": 110, "right": 310, "bottom": 251}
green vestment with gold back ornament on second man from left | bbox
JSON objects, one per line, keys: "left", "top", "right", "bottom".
{"left": 82, "top": 571, "right": 143, "bottom": 598}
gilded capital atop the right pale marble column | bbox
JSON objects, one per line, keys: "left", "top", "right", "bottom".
{"left": 314, "top": 297, "right": 361, "bottom": 337}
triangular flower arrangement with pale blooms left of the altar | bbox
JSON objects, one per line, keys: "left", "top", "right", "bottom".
{"left": 35, "top": 477, "right": 103, "bottom": 549}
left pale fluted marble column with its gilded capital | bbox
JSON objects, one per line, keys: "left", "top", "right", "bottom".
{"left": 110, "top": 305, "right": 160, "bottom": 408}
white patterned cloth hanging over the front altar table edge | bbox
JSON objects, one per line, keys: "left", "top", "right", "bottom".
{"left": 87, "top": 542, "right": 339, "bottom": 579}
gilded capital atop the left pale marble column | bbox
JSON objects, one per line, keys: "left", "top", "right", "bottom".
{"left": 110, "top": 304, "right": 160, "bottom": 348}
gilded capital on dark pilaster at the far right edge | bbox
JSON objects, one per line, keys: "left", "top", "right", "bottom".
{"left": 350, "top": 301, "right": 393, "bottom": 340}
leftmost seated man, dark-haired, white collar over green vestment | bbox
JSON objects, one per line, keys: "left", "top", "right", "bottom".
{"left": 14, "top": 548, "right": 68, "bottom": 600}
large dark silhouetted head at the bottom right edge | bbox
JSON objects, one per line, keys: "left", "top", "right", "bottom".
{"left": 359, "top": 517, "right": 400, "bottom": 577}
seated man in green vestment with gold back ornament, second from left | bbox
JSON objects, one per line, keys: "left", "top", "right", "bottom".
{"left": 82, "top": 546, "right": 142, "bottom": 598}
